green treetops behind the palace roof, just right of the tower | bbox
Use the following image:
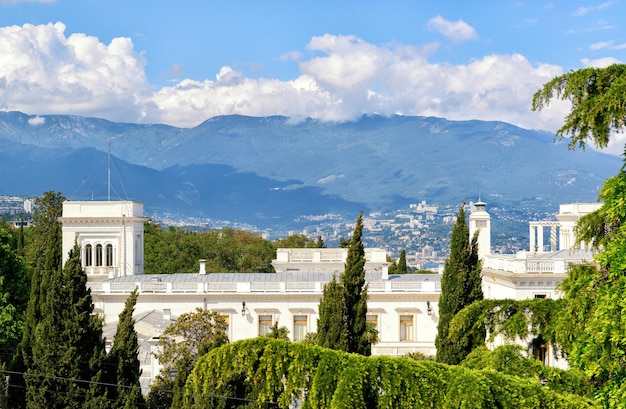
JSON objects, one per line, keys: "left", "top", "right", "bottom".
{"left": 144, "top": 223, "right": 276, "bottom": 274}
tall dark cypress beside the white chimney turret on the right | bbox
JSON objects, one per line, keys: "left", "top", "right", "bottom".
{"left": 435, "top": 203, "right": 485, "bottom": 365}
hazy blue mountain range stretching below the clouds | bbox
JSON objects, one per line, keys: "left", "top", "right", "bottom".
{"left": 0, "top": 112, "right": 621, "bottom": 227}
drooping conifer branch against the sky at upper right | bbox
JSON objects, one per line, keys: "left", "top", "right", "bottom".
{"left": 532, "top": 64, "right": 626, "bottom": 149}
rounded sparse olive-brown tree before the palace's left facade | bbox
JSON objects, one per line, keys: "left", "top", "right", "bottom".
{"left": 153, "top": 308, "right": 228, "bottom": 407}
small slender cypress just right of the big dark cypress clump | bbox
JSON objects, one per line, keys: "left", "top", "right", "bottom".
{"left": 105, "top": 289, "right": 145, "bottom": 408}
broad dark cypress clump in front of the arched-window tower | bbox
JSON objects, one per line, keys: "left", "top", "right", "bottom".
{"left": 26, "top": 245, "right": 106, "bottom": 409}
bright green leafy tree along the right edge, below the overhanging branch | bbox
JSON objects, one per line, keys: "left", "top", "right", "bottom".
{"left": 559, "top": 162, "right": 626, "bottom": 407}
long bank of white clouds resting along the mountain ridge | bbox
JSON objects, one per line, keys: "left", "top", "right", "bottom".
{"left": 0, "top": 23, "right": 567, "bottom": 135}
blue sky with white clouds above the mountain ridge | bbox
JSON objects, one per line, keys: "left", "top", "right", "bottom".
{"left": 0, "top": 0, "right": 626, "bottom": 154}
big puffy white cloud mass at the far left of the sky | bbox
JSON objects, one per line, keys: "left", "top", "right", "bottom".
{"left": 0, "top": 23, "right": 150, "bottom": 121}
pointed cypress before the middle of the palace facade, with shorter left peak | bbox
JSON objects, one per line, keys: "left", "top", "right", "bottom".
{"left": 317, "top": 212, "right": 368, "bottom": 355}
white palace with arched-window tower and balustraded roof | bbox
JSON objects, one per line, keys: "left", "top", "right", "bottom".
{"left": 60, "top": 201, "right": 599, "bottom": 386}
